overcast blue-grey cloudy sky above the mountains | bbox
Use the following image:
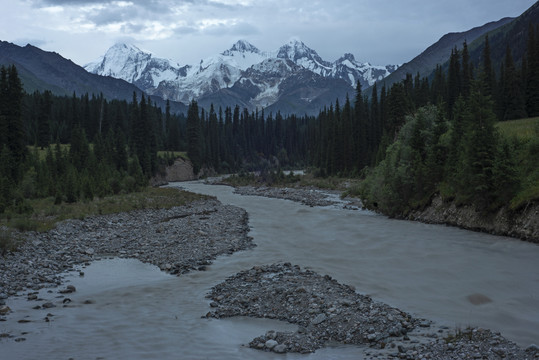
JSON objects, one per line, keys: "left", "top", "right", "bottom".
{"left": 0, "top": 0, "right": 535, "bottom": 65}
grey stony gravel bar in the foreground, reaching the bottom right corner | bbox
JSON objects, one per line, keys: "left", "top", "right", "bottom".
{"left": 206, "top": 263, "right": 539, "bottom": 359}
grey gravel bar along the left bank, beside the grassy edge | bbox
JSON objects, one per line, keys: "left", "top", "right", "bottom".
{"left": 0, "top": 199, "right": 254, "bottom": 302}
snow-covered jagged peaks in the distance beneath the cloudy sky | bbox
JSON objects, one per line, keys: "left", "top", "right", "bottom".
{"left": 85, "top": 39, "right": 397, "bottom": 111}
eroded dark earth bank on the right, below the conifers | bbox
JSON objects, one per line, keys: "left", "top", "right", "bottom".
{"left": 407, "top": 195, "right": 539, "bottom": 243}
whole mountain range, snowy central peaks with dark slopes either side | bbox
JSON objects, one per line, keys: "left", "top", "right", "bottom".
{"left": 0, "top": 2, "right": 539, "bottom": 115}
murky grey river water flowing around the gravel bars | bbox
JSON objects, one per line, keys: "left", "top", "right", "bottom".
{"left": 0, "top": 182, "right": 539, "bottom": 359}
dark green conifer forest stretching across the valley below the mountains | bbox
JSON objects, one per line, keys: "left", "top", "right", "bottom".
{"left": 0, "top": 26, "right": 539, "bottom": 215}
